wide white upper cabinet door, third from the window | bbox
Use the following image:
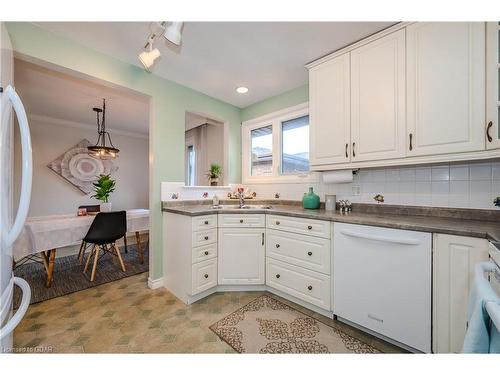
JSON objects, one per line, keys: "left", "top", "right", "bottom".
{"left": 406, "top": 22, "right": 486, "bottom": 156}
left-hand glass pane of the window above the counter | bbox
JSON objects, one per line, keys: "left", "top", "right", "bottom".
{"left": 251, "top": 125, "right": 273, "bottom": 176}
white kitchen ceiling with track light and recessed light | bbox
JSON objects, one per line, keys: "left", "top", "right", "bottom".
{"left": 37, "top": 22, "right": 394, "bottom": 107}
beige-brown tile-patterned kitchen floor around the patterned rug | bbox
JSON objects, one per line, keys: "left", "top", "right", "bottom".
{"left": 14, "top": 273, "right": 403, "bottom": 353}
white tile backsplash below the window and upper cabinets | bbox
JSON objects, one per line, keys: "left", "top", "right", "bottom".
{"left": 244, "top": 161, "right": 500, "bottom": 209}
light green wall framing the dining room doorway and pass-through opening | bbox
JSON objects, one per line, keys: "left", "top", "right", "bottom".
{"left": 6, "top": 22, "right": 241, "bottom": 279}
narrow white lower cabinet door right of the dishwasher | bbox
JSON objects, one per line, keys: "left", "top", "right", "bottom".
{"left": 432, "top": 234, "right": 488, "bottom": 353}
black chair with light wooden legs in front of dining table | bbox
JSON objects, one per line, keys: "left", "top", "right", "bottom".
{"left": 83, "top": 211, "right": 127, "bottom": 281}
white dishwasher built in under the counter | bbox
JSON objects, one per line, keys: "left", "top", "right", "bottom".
{"left": 333, "top": 223, "right": 432, "bottom": 353}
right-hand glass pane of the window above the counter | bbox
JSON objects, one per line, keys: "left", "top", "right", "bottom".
{"left": 281, "top": 115, "right": 309, "bottom": 174}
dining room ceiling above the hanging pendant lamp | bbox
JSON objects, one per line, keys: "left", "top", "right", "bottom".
{"left": 14, "top": 59, "right": 149, "bottom": 135}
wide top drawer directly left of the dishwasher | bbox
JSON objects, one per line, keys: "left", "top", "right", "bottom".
{"left": 267, "top": 215, "right": 330, "bottom": 238}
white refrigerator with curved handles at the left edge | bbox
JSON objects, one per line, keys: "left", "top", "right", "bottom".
{"left": 0, "top": 23, "right": 32, "bottom": 353}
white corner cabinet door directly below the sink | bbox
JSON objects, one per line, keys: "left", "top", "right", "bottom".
{"left": 218, "top": 228, "right": 266, "bottom": 285}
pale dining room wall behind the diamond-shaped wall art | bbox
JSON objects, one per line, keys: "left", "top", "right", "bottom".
{"left": 14, "top": 116, "right": 149, "bottom": 216}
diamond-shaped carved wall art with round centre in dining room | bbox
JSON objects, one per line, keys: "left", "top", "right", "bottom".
{"left": 47, "top": 139, "right": 118, "bottom": 194}
